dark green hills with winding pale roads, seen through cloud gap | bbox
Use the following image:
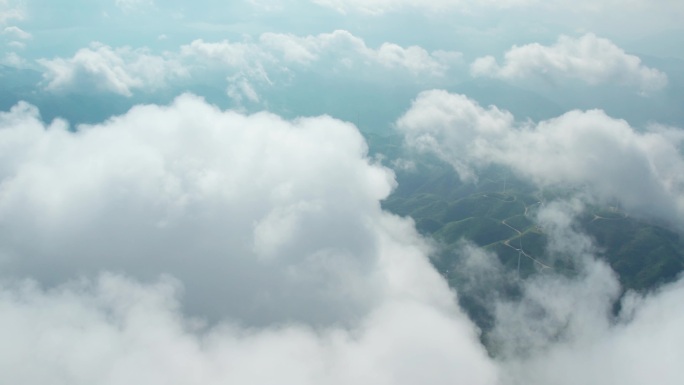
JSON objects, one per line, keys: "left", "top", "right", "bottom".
{"left": 369, "top": 130, "right": 684, "bottom": 301}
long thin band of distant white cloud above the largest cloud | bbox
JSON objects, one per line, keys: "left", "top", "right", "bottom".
{"left": 38, "top": 30, "right": 462, "bottom": 97}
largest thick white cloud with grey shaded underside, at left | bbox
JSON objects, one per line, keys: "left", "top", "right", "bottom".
{"left": 0, "top": 95, "right": 393, "bottom": 322}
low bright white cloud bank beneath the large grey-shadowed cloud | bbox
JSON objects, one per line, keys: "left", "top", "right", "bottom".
{"left": 0, "top": 275, "right": 495, "bottom": 385}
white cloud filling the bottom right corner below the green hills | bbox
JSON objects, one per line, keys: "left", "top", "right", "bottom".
{"left": 505, "top": 276, "right": 684, "bottom": 385}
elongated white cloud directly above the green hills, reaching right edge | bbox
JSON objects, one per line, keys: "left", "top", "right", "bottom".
{"left": 396, "top": 90, "right": 684, "bottom": 226}
